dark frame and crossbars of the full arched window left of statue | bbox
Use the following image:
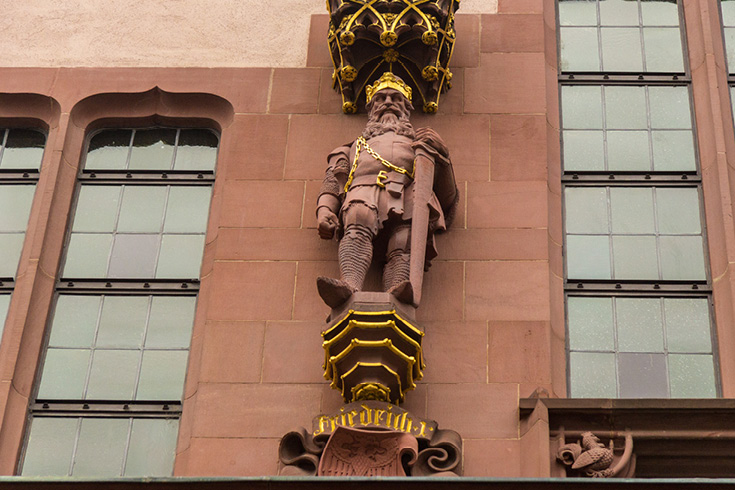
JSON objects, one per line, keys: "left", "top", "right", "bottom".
{"left": 17, "top": 124, "right": 222, "bottom": 476}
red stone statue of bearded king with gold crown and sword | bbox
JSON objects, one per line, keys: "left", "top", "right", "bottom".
{"left": 316, "top": 72, "right": 459, "bottom": 308}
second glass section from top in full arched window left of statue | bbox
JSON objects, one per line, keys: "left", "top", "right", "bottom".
{"left": 62, "top": 185, "right": 212, "bottom": 279}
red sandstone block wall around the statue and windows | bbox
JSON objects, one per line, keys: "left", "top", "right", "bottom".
{"left": 0, "top": 0, "right": 735, "bottom": 477}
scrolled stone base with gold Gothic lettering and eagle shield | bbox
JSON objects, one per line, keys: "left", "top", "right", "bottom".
{"left": 279, "top": 401, "right": 462, "bottom": 476}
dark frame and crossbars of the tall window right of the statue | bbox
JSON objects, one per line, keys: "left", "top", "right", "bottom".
{"left": 555, "top": 0, "right": 722, "bottom": 397}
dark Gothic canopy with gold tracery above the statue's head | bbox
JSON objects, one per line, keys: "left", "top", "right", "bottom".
{"left": 327, "top": 0, "right": 459, "bottom": 114}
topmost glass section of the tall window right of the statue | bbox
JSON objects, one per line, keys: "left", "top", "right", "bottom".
{"left": 559, "top": 0, "right": 685, "bottom": 73}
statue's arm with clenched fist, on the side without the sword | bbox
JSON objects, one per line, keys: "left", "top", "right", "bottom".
{"left": 316, "top": 145, "right": 350, "bottom": 240}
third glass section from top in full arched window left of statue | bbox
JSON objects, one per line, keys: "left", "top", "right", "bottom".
{"left": 38, "top": 294, "right": 196, "bottom": 401}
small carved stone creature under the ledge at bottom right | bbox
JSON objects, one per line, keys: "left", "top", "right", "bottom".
{"left": 556, "top": 432, "right": 635, "bottom": 478}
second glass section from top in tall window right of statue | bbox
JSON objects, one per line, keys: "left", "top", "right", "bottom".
{"left": 561, "top": 85, "right": 696, "bottom": 172}
